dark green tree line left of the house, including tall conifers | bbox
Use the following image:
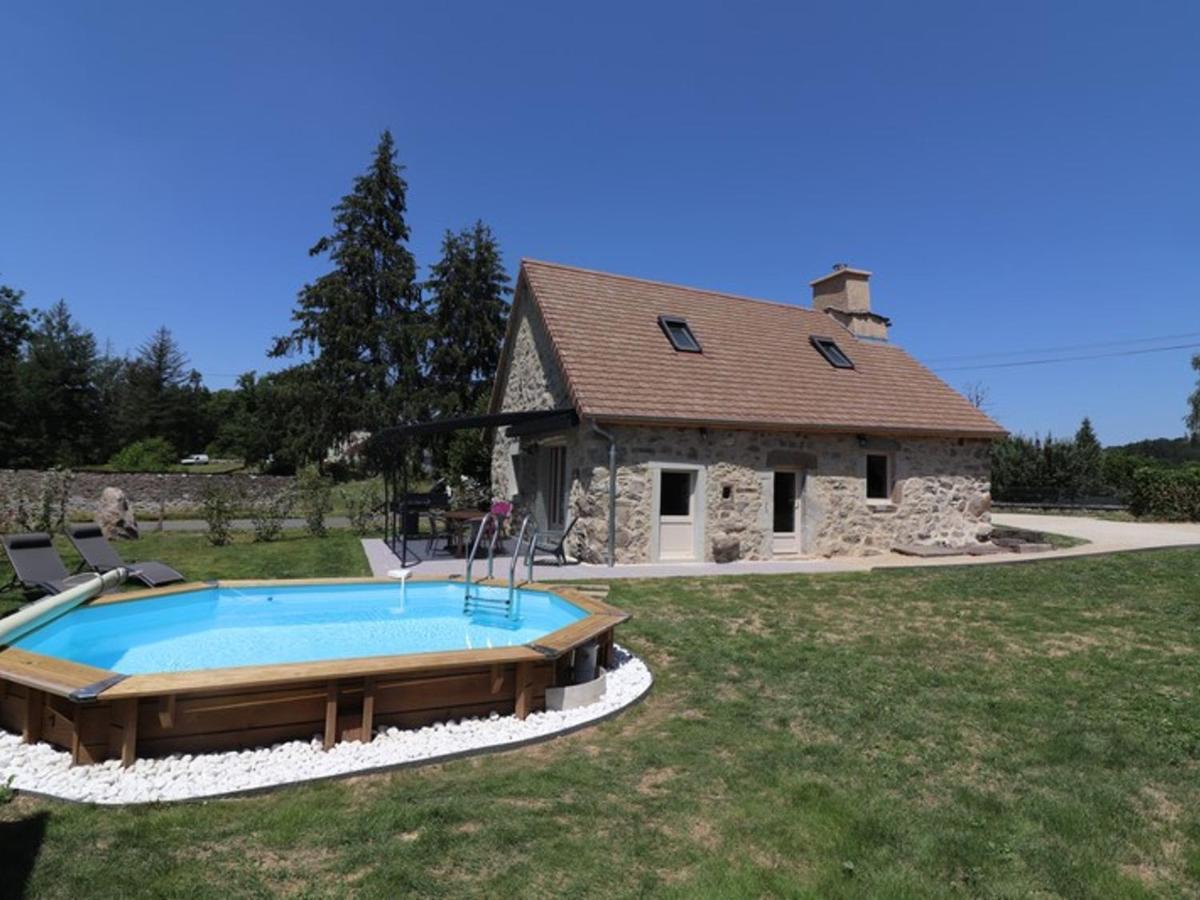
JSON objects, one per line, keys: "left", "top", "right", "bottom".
{"left": 0, "top": 131, "right": 511, "bottom": 479}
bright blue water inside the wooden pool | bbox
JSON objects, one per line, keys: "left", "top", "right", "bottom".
{"left": 14, "top": 582, "right": 587, "bottom": 674}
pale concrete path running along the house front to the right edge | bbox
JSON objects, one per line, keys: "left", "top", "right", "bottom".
{"left": 362, "top": 514, "right": 1200, "bottom": 581}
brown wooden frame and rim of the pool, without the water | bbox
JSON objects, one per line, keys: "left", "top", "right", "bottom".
{"left": 0, "top": 577, "right": 629, "bottom": 766}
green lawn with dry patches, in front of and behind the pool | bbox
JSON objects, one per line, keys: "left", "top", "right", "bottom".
{"left": 0, "top": 536, "right": 1200, "bottom": 899}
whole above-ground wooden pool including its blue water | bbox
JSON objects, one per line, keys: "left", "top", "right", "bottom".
{"left": 0, "top": 578, "right": 628, "bottom": 764}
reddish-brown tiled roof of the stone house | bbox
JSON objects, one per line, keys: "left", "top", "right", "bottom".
{"left": 521, "top": 259, "right": 1004, "bottom": 437}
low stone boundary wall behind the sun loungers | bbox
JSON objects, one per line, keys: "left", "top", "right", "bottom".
{"left": 0, "top": 469, "right": 295, "bottom": 517}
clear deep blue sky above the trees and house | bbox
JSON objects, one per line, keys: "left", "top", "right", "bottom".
{"left": 0, "top": 1, "right": 1200, "bottom": 443}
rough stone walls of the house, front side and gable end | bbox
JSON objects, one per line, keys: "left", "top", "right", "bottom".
{"left": 492, "top": 285, "right": 991, "bottom": 563}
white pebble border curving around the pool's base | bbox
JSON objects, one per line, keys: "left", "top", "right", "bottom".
{"left": 0, "top": 647, "right": 653, "bottom": 805}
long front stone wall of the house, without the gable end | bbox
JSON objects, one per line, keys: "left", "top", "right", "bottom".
{"left": 561, "top": 427, "right": 991, "bottom": 563}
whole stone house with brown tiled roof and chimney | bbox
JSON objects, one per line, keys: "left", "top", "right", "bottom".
{"left": 491, "top": 260, "right": 1004, "bottom": 563}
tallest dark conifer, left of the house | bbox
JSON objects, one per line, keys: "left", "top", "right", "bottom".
{"left": 271, "top": 131, "right": 427, "bottom": 460}
